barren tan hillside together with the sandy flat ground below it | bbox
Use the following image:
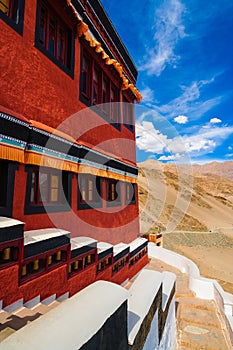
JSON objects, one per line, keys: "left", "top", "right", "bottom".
{"left": 139, "top": 160, "right": 233, "bottom": 294}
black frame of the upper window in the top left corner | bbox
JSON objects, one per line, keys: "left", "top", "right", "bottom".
{"left": 0, "top": 0, "right": 25, "bottom": 35}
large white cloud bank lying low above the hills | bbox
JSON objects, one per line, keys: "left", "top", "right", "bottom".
{"left": 136, "top": 121, "right": 233, "bottom": 160}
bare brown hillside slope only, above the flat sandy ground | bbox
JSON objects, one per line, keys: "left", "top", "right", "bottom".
{"left": 138, "top": 160, "right": 233, "bottom": 233}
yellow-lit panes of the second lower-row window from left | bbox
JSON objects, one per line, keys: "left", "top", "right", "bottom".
{"left": 30, "top": 169, "right": 62, "bottom": 205}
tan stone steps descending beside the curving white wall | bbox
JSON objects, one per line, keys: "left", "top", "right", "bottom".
{"left": 146, "top": 258, "right": 232, "bottom": 350}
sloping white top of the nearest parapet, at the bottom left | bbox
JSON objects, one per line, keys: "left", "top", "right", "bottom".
{"left": 0, "top": 281, "right": 129, "bottom": 350}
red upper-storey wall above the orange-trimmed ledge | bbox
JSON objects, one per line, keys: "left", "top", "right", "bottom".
{"left": 0, "top": 0, "right": 136, "bottom": 162}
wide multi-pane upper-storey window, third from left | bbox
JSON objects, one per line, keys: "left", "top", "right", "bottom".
{"left": 80, "top": 48, "right": 119, "bottom": 126}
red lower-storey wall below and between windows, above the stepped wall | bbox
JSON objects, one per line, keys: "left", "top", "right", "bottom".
{"left": 13, "top": 164, "right": 139, "bottom": 244}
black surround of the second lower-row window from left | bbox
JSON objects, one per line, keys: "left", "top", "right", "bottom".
{"left": 24, "top": 165, "right": 73, "bottom": 215}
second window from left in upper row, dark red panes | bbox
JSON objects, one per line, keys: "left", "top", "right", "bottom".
{"left": 36, "top": 2, "right": 73, "bottom": 70}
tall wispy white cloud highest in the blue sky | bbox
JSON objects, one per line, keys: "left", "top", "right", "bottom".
{"left": 140, "top": 0, "right": 186, "bottom": 76}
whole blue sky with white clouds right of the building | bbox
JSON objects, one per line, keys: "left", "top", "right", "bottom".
{"left": 102, "top": 0, "right": 233, "bottom": 163}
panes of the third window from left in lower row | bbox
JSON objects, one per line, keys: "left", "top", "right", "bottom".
{"left": 78, "top": 174, "right": 102, "bottom": 209}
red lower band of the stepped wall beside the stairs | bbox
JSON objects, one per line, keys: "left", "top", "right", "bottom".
{"left": 0, "top": 255, "right": 148, "bottom": 308}
